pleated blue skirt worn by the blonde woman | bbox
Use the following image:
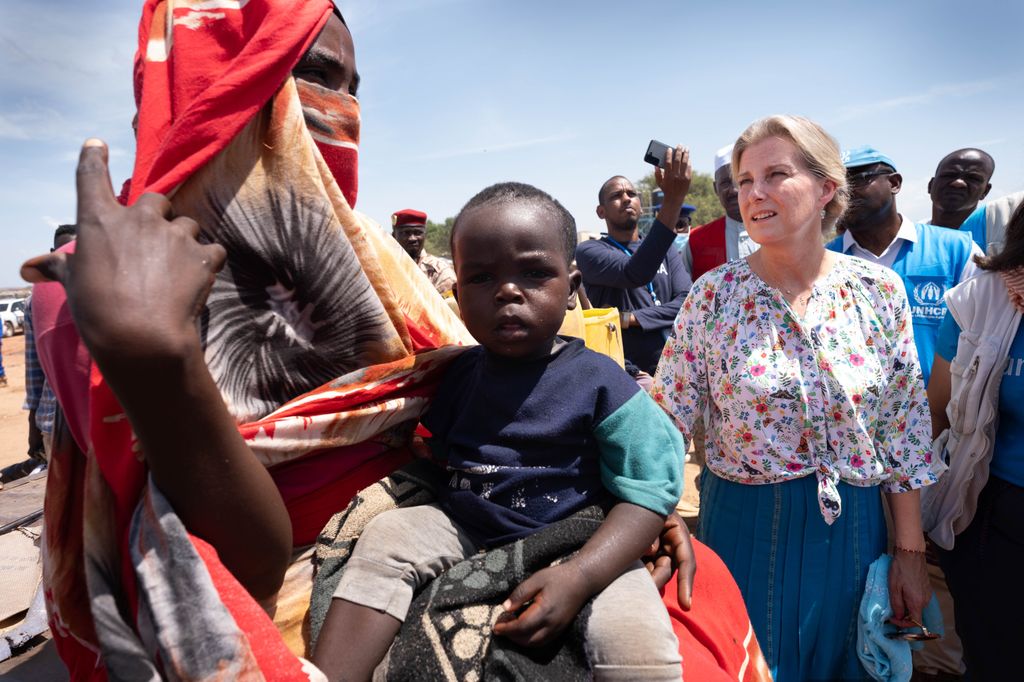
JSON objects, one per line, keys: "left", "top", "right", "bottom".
{"left": 697, "top": 468, "right": 887, "bottom": 682}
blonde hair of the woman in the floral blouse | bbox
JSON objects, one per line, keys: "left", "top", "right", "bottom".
{"left": 732, "top": 115, "right": 849, "bottom": 233}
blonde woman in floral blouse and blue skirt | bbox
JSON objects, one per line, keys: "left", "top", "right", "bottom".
{"left": 653, "top": 116, "right": 936, "bottom": 682}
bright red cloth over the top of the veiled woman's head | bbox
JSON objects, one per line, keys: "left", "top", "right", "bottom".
{"left": 129, "top": 0, "right": 336, "bottom": 203}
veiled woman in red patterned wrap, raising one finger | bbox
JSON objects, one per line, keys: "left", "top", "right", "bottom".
{"left": 25, "top": 0, "right": 469, "bottom": 679}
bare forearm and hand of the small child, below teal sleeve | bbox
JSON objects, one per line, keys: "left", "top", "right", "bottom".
{"left": 495, "top": 502, "right": 665, "bottom": 646}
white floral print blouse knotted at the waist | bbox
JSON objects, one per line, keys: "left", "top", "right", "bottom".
{"left": 651, "top": 255, "right": 941, "bottom": 524}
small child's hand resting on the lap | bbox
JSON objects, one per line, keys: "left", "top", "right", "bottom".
{"left": 495, "top": 561, "right": 591, "bottom": 646}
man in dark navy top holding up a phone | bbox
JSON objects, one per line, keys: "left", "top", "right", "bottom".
{"left": 575, "top": 146, "right": 692, "bottom": 374}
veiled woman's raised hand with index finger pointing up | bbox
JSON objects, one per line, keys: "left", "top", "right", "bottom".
{"left": 22, "top": 139, "right": 225, "bottom": 374}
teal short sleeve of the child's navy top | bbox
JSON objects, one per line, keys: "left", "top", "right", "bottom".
{"left": 594, "top": 390, "right": 686, "bottom": 515}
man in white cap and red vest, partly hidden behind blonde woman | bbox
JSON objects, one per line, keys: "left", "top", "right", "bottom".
{"left": 682, "top": 144, "right": 758, "bottom": 282}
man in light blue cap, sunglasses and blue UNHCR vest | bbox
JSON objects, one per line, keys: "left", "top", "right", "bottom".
{"left": 826, "top": 146, "right": 983, "bottom": 386}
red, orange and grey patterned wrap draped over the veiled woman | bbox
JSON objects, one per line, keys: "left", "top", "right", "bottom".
{"left": 44, "top": 0, "right": 472, "bottom": 680}
